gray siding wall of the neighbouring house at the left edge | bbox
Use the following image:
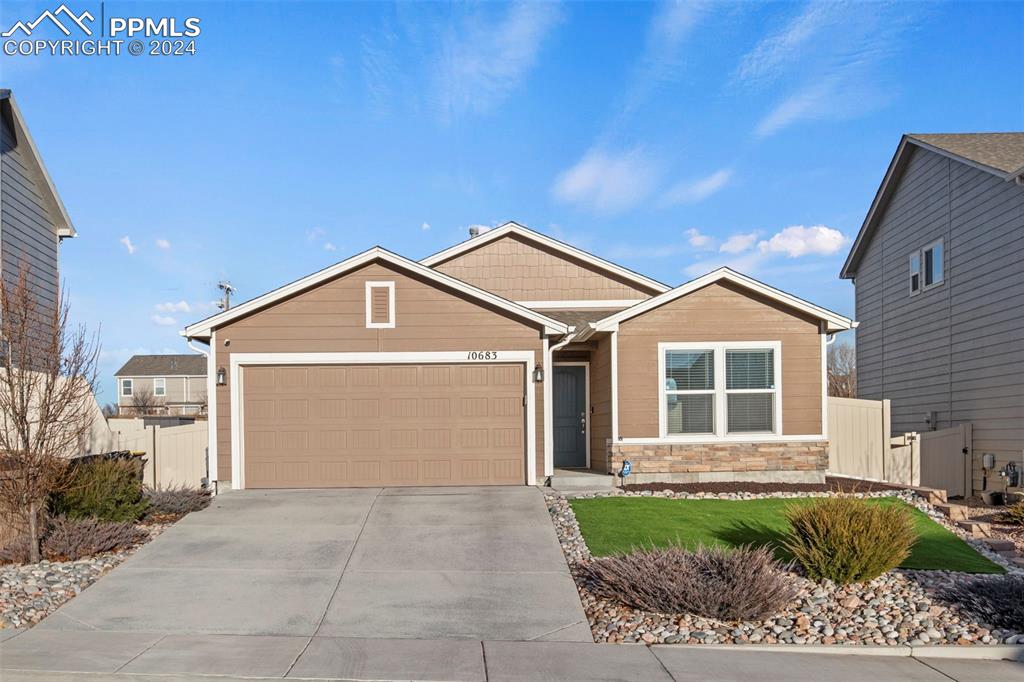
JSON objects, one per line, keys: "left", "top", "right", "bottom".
{"left": 0, "top": 114, "right": 59, "bottom": 315}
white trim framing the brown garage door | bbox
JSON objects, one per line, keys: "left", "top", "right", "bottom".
{"left": 229, "top": 349, "right": 537, "bottom": 491}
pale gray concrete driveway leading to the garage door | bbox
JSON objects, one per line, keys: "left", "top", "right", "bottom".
{"left": 36, "top": 487, "right": 593, "bottom": 642}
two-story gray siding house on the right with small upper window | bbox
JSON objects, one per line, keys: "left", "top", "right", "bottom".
{"left": 841, "top": 132, "right": 1024, "bottom": 489}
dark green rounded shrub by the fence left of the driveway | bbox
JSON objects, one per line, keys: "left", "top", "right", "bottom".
{"left": 50, "top": 458, "right": 148, "bottom": 521}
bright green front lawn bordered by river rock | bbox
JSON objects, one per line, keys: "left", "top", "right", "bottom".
{"left": 571, "top": 498, "right": 1006, "bottom": 573}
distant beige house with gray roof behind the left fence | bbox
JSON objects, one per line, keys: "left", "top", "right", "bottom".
{"left": 114, "top": 355, "right": 206, "bottom": 415}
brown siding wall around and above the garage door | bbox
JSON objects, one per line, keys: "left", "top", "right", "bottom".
{"left": 215, "top": 262, "right": 544, "bottom": 480}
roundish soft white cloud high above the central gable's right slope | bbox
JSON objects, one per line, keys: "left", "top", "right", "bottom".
{"left": 552, "top": 148, "right": 659, "bottom": 213}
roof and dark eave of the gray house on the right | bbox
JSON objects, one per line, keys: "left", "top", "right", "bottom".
{"left": 840, "top": 132, "right": 1024, "bottom": 280}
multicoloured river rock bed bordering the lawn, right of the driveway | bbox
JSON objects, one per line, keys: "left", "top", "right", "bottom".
{"left": 546, "top": 492, "right": 1024, "bottom": 646}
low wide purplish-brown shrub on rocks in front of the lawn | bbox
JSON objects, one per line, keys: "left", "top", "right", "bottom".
{"left": 585, "top": 546, "right": 798, "bottom": 621}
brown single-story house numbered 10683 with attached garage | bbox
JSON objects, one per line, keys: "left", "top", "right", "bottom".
{"left": 182, "top": 222, "right": 854, "bottom": 488}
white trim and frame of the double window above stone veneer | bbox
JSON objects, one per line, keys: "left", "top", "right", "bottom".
{"left": 655, "top": 341, "right": 782, "bottom": 442}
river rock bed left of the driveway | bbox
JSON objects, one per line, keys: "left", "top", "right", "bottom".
{"left": 0, "top": 524, "right": 167, "bottom": 629}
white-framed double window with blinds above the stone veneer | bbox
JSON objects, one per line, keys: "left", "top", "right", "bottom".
{"left": 658, "top": 341, "right": 782, "bottom": 440}
